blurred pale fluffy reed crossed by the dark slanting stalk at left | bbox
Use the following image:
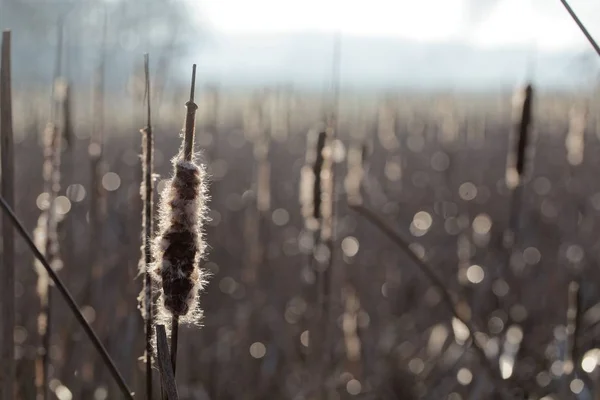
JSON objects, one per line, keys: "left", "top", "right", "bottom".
{"left": 34, "top": 123, "right": 62, "bottom": 399}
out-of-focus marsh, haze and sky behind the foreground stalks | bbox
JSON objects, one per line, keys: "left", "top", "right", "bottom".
{"left": 0, "top": 0, "right": 600, "bottom": 400}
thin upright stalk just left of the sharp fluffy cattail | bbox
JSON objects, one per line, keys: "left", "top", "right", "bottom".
{"left": 138, "top": 54, "right": 154, "bottom": 400}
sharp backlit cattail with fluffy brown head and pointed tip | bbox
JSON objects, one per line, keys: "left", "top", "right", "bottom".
{"left": 153, "top": 64, "right": 207, "bottom": 373}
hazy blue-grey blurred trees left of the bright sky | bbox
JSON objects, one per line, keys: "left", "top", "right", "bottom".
{"left": 0, "top": 0, "right": 200, "bottom": 88}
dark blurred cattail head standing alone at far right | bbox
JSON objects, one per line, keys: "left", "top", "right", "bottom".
{"left": 506, "top": 84, "right": 533, "bottom": 188}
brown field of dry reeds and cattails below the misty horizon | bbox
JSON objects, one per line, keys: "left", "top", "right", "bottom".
{"left": 0, "top": 25, "right": 600, "bottom": 400}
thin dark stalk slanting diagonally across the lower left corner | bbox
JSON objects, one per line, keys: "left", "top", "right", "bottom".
{"left": 0, "top": 196, "right": 133, "bottom": 400}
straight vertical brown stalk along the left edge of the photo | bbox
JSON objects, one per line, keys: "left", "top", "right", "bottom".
{"left": 0, "top": 31, "right": 16, "bottom": 400}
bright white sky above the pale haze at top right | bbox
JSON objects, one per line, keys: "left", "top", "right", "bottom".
{"left": 195, "top": 0, "right": 600, "bottom": 51}
